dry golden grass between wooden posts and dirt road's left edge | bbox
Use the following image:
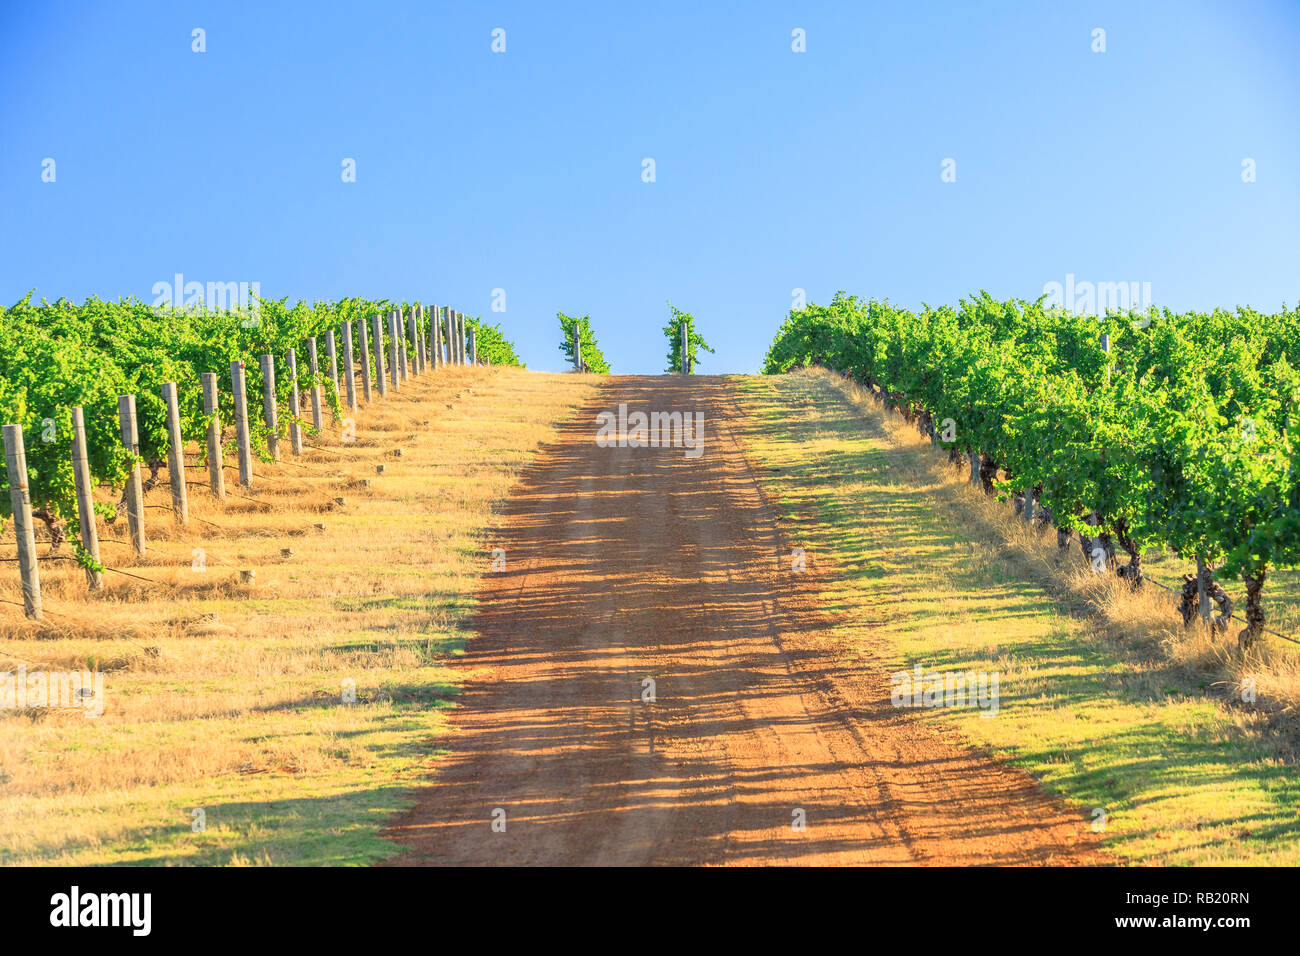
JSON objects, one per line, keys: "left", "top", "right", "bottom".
{"left": 0, "top": 368, "right": 593, "bottom": 865}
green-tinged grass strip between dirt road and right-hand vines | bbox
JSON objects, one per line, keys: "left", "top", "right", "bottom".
{"left": 733, "top": 371, "right": 1300, "bottom": 865}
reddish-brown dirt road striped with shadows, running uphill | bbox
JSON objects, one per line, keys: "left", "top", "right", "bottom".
{"left": 386, "top": 376, "right": 1109, "bottom": 865}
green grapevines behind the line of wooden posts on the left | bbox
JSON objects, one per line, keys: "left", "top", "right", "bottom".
{"left": 0, "top": 294, "right": 520, "bottom": 572}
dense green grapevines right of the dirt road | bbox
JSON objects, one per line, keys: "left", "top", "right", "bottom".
{"left": 763, "top": 293, "right": 1300, "bottom": 648}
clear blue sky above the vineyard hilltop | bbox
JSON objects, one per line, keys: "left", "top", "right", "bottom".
{"left": 0, "top": 0, "right": 1300, "bottom": 372}
